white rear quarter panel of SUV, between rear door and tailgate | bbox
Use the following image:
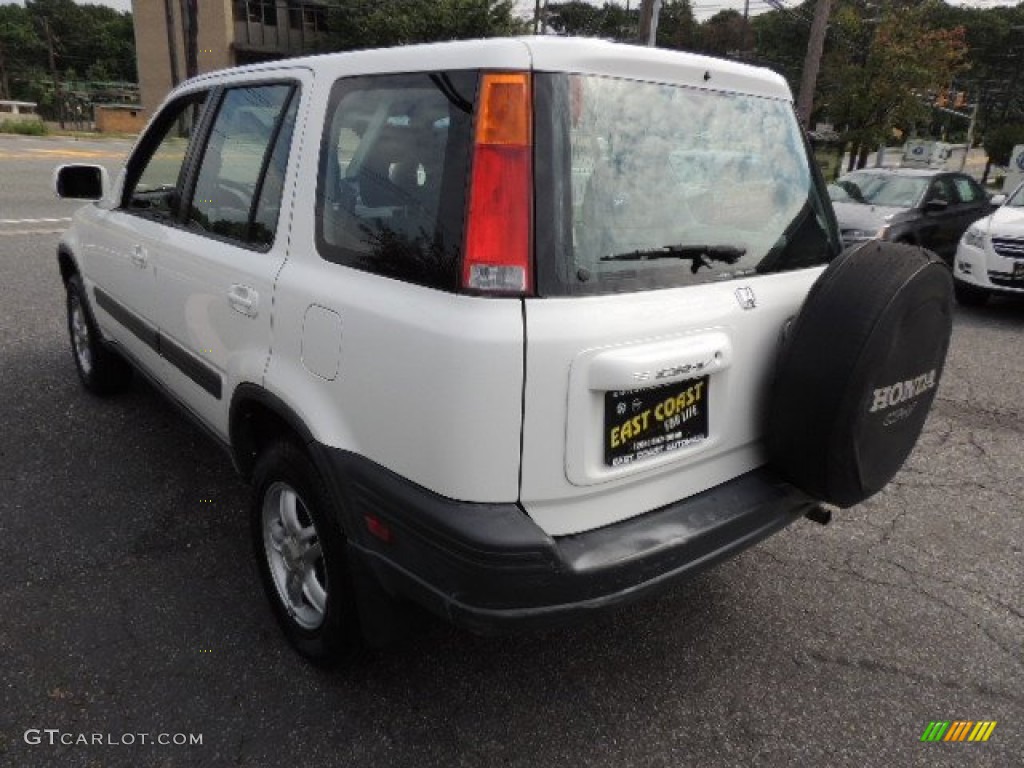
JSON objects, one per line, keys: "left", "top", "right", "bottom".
{"left": 265, "top": 259, "right": 523, "bottom": 502}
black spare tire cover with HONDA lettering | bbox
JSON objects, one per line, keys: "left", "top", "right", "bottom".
{"left": 765, "top": 241, "right": 952, "bottom": 507}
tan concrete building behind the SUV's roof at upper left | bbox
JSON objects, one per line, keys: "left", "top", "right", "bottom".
{"left": 132, "top": 0, "right": 328, "bottom": 116}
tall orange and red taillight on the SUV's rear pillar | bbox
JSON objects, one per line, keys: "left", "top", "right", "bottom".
{"left": 462, "top": 72, "right": 534, "bottom": 294}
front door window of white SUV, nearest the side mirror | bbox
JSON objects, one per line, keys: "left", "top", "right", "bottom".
{"left": 123, "top": 91, "right": 207, "bottom": 220}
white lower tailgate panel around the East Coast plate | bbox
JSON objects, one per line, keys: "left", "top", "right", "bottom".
{"left": 521, "top": 268, "right": 821, "bottom": 536}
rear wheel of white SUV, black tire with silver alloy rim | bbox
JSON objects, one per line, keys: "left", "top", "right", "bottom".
{"left": 250, "top": 442, "right": 360, "bottom": 666}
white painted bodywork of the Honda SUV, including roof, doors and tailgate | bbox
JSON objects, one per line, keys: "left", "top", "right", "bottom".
{"left": 59, "top": 38, "right": 820, "bottom": 535}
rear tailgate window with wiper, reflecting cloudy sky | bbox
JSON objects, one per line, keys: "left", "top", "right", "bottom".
{"left": 536, "top": 75, "right": 840, "bottom": 295}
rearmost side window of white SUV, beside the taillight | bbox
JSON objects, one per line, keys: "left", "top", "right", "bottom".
{"left": 316, "top": 72, "right": 478, "bottom": 291}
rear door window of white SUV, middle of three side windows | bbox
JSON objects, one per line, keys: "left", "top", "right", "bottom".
{"left": 188, "top": 84, "right": 294, "bottom": 246}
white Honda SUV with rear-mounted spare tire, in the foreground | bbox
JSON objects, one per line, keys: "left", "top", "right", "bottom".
{"left": 56, "top": 38, "right": 951, "bottom": 663}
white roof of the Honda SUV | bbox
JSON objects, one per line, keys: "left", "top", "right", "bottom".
{"left": 181, "top": 36, "right": 793, "bottom": 101}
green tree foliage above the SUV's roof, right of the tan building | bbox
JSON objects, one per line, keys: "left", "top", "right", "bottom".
{"left": 330, "top": 0, "right": 528, "bottom": 50}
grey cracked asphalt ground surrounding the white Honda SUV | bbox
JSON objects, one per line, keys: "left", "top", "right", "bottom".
{"left": 0, "top": 137, "right": 1024, "bottom": 768}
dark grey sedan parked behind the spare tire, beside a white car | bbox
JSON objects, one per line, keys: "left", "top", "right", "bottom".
{"left": 828, "top": 168, "right": 992, "bottom": 265}
